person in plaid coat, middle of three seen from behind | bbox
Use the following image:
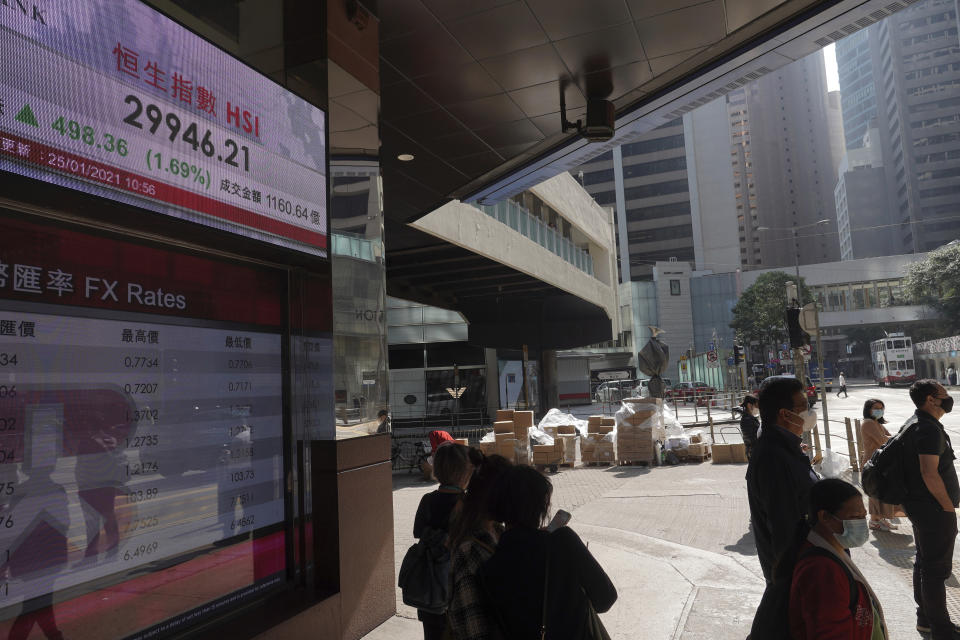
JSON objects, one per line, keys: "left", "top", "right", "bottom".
{"left": 447, "top": 448, "right": 513, "bottom": 640}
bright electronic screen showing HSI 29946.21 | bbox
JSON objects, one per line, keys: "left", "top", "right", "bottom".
{"left": 0, "top": 0, "right": 327, "bottom": 256}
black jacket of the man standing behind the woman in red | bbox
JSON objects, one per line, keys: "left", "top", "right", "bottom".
{"left": 747, "top": 425, "right": 817, "bottom": 583}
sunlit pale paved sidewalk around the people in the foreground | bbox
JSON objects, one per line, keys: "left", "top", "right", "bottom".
{"left": 366, "top": 462, "right": 944, "bottom": 640}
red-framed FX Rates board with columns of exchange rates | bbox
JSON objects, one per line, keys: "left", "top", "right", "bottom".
{"left": 0, "top": 216, "right": 302, "bottom": 640}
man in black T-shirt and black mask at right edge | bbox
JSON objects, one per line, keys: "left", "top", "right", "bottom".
{"left": 901, "top": 380, "right": 960, "bottom": 640}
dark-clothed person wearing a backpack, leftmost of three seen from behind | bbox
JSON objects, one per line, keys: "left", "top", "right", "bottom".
{"left": 413, "top": 442, "right": 472, "bottom": 640}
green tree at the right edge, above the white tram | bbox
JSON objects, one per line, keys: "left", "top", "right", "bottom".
{"left": 903, "top": 240, "right": 960, "bottom": 335}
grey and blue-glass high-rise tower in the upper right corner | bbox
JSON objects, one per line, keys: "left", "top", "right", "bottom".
{"left": 837, "top": 0, "right": 960, "bottom": 253}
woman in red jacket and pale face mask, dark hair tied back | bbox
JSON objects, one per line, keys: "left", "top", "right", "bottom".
{"left": 790, "top": 478, "right": 888, "bottom": 640}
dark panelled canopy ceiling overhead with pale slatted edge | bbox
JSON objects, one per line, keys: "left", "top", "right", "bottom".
{"left": 377, "top": 0, "right": 916, "bottom": 338}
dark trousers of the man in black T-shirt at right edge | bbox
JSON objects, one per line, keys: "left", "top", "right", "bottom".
{"left": 910, "top": 509, "right": 957, "bottom": 640}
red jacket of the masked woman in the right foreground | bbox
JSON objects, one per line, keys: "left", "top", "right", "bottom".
{"left": 790, "top": 541, "right": 873, "bottom": 640}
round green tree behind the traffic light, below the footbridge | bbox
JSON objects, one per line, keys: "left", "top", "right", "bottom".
{"left": 730, "top": 271, "right": 813, "bottom": 360}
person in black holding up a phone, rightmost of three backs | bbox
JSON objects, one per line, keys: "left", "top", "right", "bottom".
{"left": 480, "top": 465, "right": 617, "bottom": 640}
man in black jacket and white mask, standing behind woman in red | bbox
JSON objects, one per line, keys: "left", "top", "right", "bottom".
{"left": 747, "top": 378, "right": 818, "bottom": 640}
